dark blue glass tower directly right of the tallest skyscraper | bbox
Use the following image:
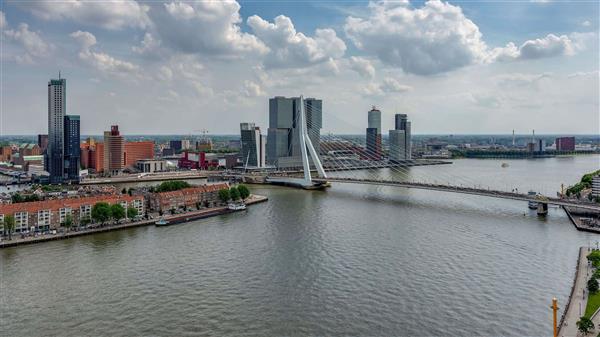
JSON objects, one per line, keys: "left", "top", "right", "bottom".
{"left": 64, "top": 115, "right": 81, "bottom": 182}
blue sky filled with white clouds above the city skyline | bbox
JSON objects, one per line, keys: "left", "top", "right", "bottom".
{"left": 0, "top": 0, "right": 600, "bottom": 135}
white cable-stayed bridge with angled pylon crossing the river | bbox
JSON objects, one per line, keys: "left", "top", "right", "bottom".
{"left": 258, "top": 96, "right": 600, "bottom": 212}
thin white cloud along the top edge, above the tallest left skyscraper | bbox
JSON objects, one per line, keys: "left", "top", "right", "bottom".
{"left": 19, "top": 0, "right": 150, "bottom": 30}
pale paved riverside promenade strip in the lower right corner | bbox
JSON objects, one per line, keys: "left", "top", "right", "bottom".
{"left": 558, "top": 247, "right": 590, "bottom": 337}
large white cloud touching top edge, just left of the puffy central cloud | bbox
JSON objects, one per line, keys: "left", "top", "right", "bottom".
{"left": 153, "top": 1, "right": 267, "bottom": 58}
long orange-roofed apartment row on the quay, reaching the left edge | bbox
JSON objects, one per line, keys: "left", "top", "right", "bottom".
{"left": 0, "top": 194, "right": 144, "bottom": 233}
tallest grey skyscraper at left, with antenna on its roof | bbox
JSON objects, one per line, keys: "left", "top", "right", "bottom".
{"left": 45, "top": 75, "right": 67, "bottom": 184}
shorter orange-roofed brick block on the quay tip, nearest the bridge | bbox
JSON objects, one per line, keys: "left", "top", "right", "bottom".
{"left": 149, "top": 183, "right": 229, "bottom": 212}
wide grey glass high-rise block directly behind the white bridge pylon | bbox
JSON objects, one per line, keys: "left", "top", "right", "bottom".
{"left": 266, "top": 96, "right": 323, "bottom": 168}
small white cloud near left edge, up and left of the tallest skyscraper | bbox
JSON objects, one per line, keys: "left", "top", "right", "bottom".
{"left": 4, "top": 23, "right": 54, "bottom": 64}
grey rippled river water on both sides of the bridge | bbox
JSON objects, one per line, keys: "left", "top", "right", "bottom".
{"left": 0, "top": 156, "right": 600, "bottom": 336}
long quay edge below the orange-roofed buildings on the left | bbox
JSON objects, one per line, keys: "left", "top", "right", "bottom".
{"left": 0, "top": 194, "right": 268, "bottom": 249}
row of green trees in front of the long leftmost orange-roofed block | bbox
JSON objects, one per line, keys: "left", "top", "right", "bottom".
{"left": 1, "top": 202, "right": 138, "bottom": 240}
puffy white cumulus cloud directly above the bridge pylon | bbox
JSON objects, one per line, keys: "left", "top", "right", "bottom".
{"left": 247, "top": 15, "right": 346, "bottom": 68}
